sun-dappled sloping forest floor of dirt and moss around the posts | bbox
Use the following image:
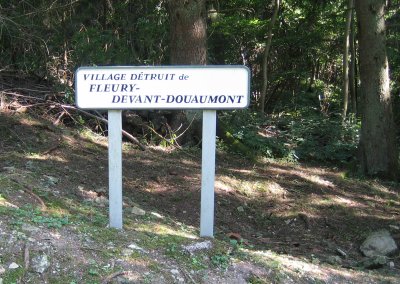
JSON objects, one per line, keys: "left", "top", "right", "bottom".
{"left": 0, "top": 105, "right": 400, "bottom": 284}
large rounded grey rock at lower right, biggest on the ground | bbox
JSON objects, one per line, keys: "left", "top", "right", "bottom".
{"left": 360, "top": 230, "right": 397, "bottom": 257}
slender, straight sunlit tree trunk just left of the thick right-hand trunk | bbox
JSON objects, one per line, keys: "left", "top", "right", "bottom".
{"left": 342, "top": 0, "right": 353, "bottom": 122}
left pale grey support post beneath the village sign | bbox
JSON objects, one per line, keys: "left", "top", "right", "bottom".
{"left": 108, "top": 110, "right": 122, "bottom": 229}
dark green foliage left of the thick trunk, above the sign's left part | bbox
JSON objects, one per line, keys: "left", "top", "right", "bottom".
{"left": 0, "top": 0, "right": 168, "bottom": 84}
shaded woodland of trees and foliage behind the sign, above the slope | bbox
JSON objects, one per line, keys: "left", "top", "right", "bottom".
{"left": 0, "top": 0, "right": 400, "bottom": 179}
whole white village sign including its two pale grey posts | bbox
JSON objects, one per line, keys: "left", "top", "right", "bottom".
{"left": 75, "top": 66, "right": 250, "bottom": 237}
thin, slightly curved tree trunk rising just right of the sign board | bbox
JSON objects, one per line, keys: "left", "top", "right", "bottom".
{"left": 260, "top": 0, "right": 280, "bottom": 113}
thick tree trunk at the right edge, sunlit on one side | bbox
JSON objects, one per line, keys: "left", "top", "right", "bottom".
{"left": 355, "top": 0, "right": 398, "bottom": 179}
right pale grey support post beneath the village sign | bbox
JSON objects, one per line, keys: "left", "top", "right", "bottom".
{"left": 200, "top": 110, "right": 217, "bottom": 237}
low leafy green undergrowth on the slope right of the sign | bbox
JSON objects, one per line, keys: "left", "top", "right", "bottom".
{"left": 221, "top": 103, "right": 360, "bottom": 164}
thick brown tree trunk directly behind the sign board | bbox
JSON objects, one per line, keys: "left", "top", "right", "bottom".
{"left": 168, "top": 0, "right": 207, "bottom": 143}
